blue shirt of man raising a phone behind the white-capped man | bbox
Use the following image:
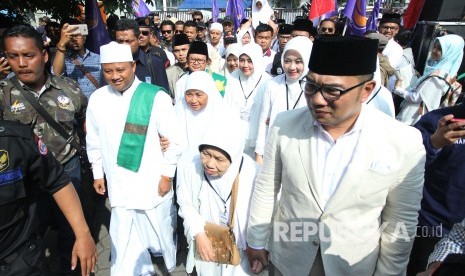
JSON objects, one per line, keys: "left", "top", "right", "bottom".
{"left": 52, "top": 49, "right": 104, "bottom": 99}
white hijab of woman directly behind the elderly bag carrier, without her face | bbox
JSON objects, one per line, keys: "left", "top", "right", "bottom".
{"left": 176, "top": 71, "right": 224, "bottom": 153}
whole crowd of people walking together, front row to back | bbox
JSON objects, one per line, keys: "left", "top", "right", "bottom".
{"left": 0, "top": 0, "right": 465, "bottom": 275}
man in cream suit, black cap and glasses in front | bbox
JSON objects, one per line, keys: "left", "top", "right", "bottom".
{"left": 247, "top": 37, "right": 425, "bottom": 276}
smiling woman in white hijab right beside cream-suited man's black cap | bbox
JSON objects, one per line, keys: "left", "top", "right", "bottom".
{"left": 255, "top": 36, "right": 313, "bottom": 164}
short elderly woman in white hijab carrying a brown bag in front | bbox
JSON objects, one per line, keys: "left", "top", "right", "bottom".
{"left": 177, "top": 114, "right": 257, "bottom": 275}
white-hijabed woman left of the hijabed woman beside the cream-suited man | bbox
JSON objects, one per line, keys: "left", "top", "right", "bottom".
{"left": 224, "top": 43, "right": 271, "bottom": 158}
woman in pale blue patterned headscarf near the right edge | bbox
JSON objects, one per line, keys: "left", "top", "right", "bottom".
{"left": 393, "top": 34, "right": 464, "bottom": 125}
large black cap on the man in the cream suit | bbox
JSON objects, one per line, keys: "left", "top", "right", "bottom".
{"left": 308, "top": 36, "right": 378, "bottom": 76}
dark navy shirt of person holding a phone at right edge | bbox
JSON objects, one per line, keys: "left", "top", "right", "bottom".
{"left": 415, "top": 104, "right": 465, "bottom": 238}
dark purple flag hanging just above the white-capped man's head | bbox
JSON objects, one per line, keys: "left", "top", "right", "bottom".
{"left": 84, "top": 0, "right": 111, "bottom": 54}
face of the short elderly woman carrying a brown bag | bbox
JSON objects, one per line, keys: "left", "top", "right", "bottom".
{"left": 200, "top": 146, "right": 231, "bottom": 177}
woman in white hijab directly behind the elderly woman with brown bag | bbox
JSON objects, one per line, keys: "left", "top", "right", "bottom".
{"left": 175, "top": 71, "right": 227, "bottom": 157}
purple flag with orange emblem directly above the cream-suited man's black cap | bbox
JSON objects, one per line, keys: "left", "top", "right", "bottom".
{"left": 344, "top": 0, "right": 367, "bottom": 36}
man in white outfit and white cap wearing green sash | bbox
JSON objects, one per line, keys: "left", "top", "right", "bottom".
{"left": 86, "top": 42, "right": 181, "bottom": 275}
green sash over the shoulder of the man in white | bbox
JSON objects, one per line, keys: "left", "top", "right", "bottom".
{"left": 116, "top": 82, "right": 162, "bottom": 172}
